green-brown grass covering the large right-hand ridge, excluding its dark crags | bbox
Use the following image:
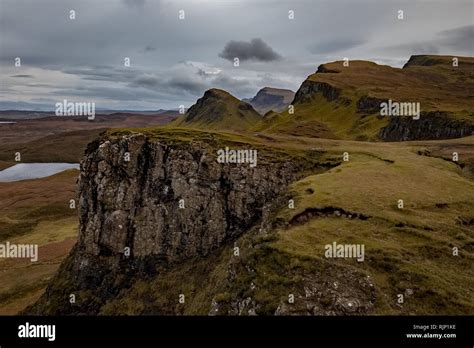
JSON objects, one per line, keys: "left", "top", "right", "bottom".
{"left": 252, "top": 56, "right": 474, "bottom": 141}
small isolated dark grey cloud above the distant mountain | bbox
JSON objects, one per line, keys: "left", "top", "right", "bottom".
{"left": 219, "top": 38, "right": 281, "bottom": 62}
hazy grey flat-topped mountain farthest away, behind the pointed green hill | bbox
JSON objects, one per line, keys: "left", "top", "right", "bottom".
{"left": 243, "top": 87, "right": 295, "bottom": 115}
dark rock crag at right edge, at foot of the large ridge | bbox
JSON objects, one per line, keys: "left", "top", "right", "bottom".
{"left": 379, "top": 111, "right": 474, "bottom": 141}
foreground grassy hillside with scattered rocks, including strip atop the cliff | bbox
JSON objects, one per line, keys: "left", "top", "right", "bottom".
{"left": 86, "top": 128, "right": 474, "bottom": 315}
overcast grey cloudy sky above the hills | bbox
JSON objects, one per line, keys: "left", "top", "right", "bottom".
{"left": 0, "top": 0, "right": 474, "bottom": 110}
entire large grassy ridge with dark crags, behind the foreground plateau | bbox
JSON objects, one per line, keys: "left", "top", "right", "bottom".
{"left": 256, "top": 56, "right": 474, "bottom": 141}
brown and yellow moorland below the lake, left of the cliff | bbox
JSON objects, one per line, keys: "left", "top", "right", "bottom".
{"left": 0, "top": 170, "right": 78, "bottom": 315}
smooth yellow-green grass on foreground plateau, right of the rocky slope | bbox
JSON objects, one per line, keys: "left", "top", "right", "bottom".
{"left": 266, "top": 137, "right": 474, "bottom": 314}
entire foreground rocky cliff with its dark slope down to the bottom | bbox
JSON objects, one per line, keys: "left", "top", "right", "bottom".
{"left": 27, "top": 134, "right": 334, "bottom": 314}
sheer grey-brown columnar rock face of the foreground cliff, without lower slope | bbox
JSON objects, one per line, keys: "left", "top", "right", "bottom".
{"left": 79, "top": 135, "right": 293, "bottom": 262}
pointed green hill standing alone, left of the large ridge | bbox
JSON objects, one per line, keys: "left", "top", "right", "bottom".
{"left": 171, "top": 88, "right": 261, "bottom": 131}
